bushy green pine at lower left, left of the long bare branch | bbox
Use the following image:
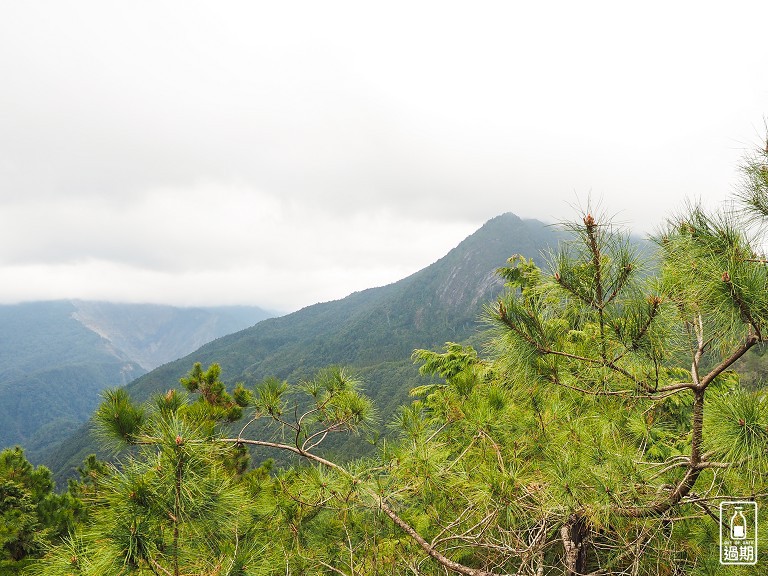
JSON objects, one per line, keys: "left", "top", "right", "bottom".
{"left": 30, "top": 374, "right": 263, "bottom": 575}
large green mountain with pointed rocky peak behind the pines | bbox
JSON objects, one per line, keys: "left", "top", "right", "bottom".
{"left": 46, "top": 214, "right": 559, "bottom": 477}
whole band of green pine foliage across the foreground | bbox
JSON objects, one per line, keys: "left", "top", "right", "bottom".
{"left": 6, "top": 137, "right": 768, "bottom": 576}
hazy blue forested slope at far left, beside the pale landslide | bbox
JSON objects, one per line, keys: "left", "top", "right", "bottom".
{"left": 0, "top": 302, "right": 146, "bottom": 448}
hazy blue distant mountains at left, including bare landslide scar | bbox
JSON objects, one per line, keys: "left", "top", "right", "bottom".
{"left": 0, "top": 301, "right": 270, "bottom": 457}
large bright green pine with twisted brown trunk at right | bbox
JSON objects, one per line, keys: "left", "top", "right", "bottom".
{"left": 380, "top": 181, "right": 768, "bottom": 574}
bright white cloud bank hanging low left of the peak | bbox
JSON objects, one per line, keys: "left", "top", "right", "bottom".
{"left": 0, "top": 185, "right": 473, "bottom": 311}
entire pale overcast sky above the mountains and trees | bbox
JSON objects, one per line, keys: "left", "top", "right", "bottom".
{"left": 0, "top": 0, "right": 768, "bottom": 311}
